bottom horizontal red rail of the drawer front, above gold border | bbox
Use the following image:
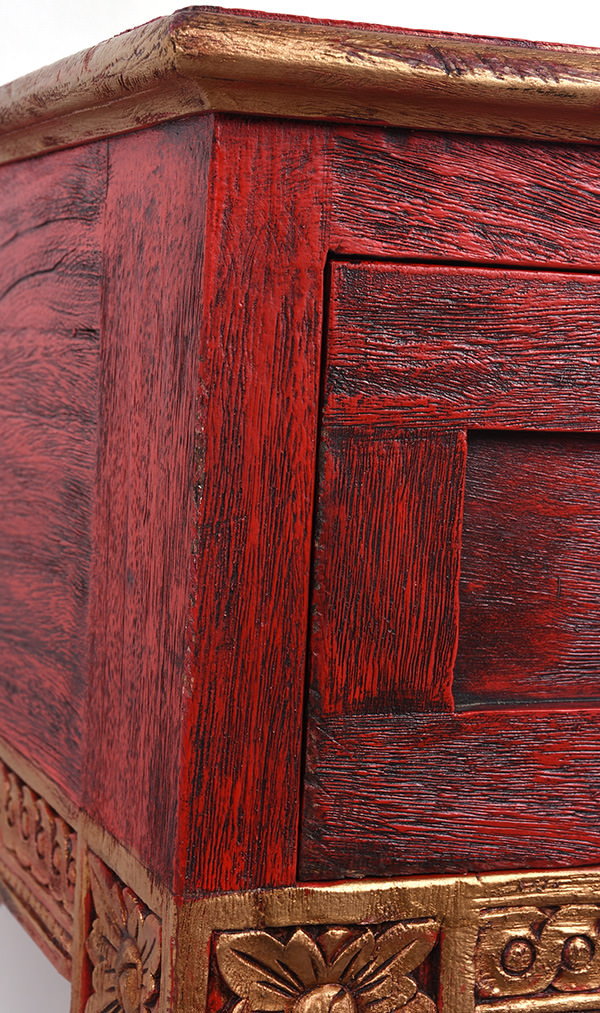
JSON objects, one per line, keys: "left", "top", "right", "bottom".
{"left": 300, "top": 710, "right": 600, "bottom": 879}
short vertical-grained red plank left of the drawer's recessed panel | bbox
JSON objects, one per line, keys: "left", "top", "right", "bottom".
{"left": 310, "top": 426, "right": 466, "bottom": 715}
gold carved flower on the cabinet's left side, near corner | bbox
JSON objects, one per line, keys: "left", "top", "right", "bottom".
{"left": 85, "top": 856, "right": 160, "bottom": 1013}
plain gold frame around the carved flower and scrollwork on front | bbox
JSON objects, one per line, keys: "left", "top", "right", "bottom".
{"left": 174, "top": 868, "right": 600, "bottom": 1013}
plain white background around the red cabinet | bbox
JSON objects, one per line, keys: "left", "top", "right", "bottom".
{"left": 0, "top": 0, "right": 600, "bottom": 1013}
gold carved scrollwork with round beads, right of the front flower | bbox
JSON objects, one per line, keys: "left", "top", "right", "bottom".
{"left": 475, "top": 905, "right": 600, "bottom": 1006}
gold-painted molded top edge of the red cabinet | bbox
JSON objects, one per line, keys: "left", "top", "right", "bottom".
{"left": 0, "top": 7, "right": 600, "bottom": 162}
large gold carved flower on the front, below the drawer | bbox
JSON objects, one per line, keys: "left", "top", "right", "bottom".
{"left": 216, "top": 919, "right": 439, "bottom": 1013}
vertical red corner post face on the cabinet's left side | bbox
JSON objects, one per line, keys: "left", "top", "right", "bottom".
{"left": 84, "top": 118, "right": 212, "bottom": 880}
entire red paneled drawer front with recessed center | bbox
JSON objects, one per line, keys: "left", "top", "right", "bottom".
{"left": 300, "top": 262, "right": 600, "bottom": 878}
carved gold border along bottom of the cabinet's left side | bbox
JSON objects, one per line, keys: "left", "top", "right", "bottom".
{"left": 0, "top": 742, "right": 171, "bottom": 1013}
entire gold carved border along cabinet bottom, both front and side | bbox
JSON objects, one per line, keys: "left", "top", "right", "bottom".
{"left": 0, "top": 744, "right": 600, "bottom": 1013}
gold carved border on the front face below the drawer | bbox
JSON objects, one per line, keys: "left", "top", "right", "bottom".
{"left": 174, "top": 869, "right": 600, "bottom": 1013}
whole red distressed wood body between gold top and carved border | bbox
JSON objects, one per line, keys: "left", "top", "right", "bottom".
{"left": 5, "top": 116, "right": 600, "bottom": 895}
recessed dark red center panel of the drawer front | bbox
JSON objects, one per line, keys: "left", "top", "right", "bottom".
{"left": 453, "top": 433, "right": 600, "bottom": 706}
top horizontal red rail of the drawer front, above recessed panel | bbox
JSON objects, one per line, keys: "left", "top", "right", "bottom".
{"left": 323, "top": 262, "right": 600, "bottom": 430}
